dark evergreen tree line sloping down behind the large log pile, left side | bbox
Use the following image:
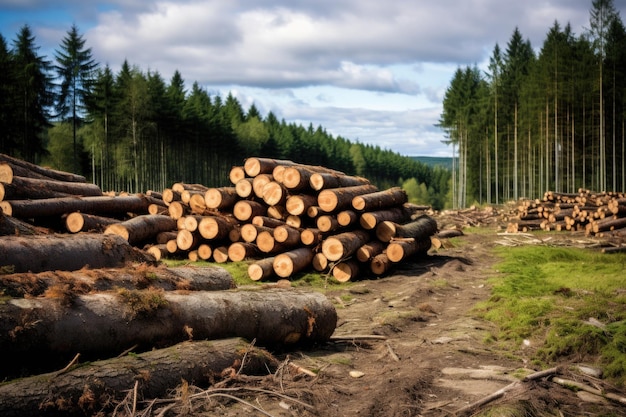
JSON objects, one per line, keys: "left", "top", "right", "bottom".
{"left": 0, "top": 25, "right": 451, "bottom": 209}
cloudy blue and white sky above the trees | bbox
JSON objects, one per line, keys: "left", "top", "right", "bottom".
{"left": 0, "top": 0, "right": 626, "bottom": 156}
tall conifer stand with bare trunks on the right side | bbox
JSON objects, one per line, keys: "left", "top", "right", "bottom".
{"left": 439, "top": 0, "right": 626, "bottom": 207}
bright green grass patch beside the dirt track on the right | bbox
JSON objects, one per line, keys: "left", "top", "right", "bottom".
{"left": 474, "top": 246, "right": 626, "bottom": 386}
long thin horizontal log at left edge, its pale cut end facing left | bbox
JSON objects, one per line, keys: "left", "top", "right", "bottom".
{"left": 0, "top": 194, "right": 151, "bottom": 219}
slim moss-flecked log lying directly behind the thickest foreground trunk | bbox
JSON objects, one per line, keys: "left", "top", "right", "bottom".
{"left": 0, "top": 265, "right": 236, "bottom": 303}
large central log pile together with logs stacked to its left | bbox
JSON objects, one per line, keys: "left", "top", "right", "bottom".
{"left": 0, "top": 155, "right": 437, "bottom": 282}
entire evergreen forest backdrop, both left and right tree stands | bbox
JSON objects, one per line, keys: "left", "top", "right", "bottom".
{"left": 0, "top": 0, "right": 626, "bottom": 209}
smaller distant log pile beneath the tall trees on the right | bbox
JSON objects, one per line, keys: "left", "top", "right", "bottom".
{"left": 507, "top": 189, "right": 626, "bottom": 237}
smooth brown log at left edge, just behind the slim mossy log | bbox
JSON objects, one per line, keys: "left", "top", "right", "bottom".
{"left": 0, "top": 233, "right": 151, "bottom": 272}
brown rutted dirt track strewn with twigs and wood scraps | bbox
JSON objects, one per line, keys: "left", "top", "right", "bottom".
{"left": 151, "top": 228, "right": 626, "bottom": 417}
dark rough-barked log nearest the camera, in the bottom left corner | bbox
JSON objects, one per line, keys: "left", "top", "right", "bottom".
{"left": 0, "top": 338, "right": 278, "bottom": 417}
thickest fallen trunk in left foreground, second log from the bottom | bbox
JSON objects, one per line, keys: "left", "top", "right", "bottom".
{"left": 0, "top": 289, "right": 337, "bottom": 378}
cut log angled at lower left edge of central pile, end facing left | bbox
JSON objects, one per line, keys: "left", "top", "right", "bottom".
{"left": 104, "top": 214, "right": 176, "bottom": 245}
